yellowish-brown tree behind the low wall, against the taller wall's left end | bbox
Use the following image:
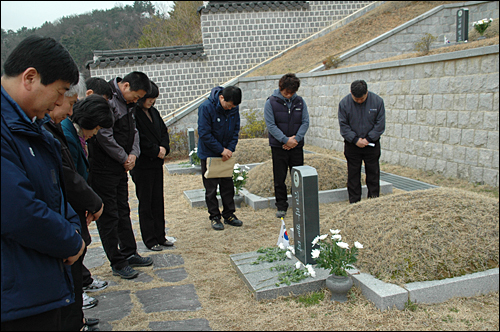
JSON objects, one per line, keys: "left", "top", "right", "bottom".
{"left": 138, "top": 1, "right": 203, "bottom": 48}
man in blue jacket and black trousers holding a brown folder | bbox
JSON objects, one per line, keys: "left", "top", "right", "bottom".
{"left": 198, "top": 86, "right": 243, "bottom": 231}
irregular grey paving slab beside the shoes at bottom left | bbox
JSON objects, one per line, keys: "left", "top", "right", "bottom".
{"left": 84, "top": 290, "right": 134, "bottom": 331}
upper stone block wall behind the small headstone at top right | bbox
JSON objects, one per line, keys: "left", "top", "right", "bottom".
{"left": 342, "top": 1, "right": 499, "bottom": 65}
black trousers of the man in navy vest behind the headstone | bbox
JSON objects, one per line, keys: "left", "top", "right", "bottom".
{"left": 271, "top": 147, "right": 304, "bottom": 211}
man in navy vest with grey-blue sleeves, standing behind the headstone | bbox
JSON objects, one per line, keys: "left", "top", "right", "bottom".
{"left": 264, "top": 74, "right": 309, "bottom": 218}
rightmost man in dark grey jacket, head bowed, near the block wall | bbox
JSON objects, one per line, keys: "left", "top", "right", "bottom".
{"left": 338, "top": 80, "right": 385, "bottom": 203}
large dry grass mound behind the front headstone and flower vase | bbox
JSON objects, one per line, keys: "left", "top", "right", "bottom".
{"left": 328, "top": 188, "right": 499, "bottom": 285}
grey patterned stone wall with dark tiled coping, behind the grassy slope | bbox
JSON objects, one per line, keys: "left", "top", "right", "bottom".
{"left": 87, "top": 1, "right": 373, "bottom": 116}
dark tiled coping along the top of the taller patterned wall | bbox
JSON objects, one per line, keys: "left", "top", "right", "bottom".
{"left": 197, "top": 1, "right": 309, "bottom": 15}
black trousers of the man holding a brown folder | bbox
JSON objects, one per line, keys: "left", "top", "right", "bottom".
{"left": 201, "top": 159, "right": 236, "bottom": 219}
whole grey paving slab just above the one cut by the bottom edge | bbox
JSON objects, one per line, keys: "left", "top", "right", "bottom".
{"left": 135, "top": 284, "right": 201, "bottom": 313}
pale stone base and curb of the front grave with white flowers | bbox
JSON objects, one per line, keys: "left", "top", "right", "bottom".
{"left": 229, "top": 251, "right": 499, "bottom": 311}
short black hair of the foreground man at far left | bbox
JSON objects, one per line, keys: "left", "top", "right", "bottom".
{"left": 3, "top": 35, "right": 79, "bottom": 85}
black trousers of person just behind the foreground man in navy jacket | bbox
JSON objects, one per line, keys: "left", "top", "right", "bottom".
{"left": 61, "top": 255, "right": 83, "bottom": 331}
